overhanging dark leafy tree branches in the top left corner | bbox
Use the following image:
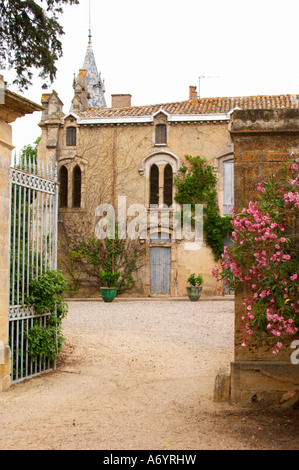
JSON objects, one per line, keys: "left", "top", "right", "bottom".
{"left": 0, "top": 0, "right": 79, "bottom": 90}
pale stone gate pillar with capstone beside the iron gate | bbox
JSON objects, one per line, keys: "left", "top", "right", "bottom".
{"left": 0, "top": 75, "right": 42, "bottom": 392}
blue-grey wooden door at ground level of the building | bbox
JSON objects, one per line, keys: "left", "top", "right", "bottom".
{"left": 150, "top": 246, "right": 171, "bottom": 294}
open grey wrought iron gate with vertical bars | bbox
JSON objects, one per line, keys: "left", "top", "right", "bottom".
{"left": 8, "top": 158, "right": 58, "bottom": 383}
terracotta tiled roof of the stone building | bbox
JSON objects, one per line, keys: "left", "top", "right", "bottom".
{"left": 80, "top": 95, "right": 299, "bottom": 119}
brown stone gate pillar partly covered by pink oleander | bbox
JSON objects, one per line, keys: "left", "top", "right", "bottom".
{"left": 230, "top": 109, "right": 299, "bottom": 402}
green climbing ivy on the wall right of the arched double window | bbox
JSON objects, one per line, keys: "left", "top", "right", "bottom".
{"left": 174, "top": 156, "right": 232, "bottom": 261}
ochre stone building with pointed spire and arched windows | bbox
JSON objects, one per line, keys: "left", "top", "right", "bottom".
{"left": 38, "top": 38, "right": 299, "bottom": 296}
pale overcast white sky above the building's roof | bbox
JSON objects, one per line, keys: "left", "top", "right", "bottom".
{"left": 2, "top": 0, "right": 299, "bottom": 154}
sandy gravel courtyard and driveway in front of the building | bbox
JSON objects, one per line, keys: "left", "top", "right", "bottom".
{"left": 0, "top": 300, "right": 296, "bottom": 450}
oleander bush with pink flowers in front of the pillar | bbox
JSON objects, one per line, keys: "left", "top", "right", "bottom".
{"left": 212, "top": 154, "right": 299, "bottom": 354}
